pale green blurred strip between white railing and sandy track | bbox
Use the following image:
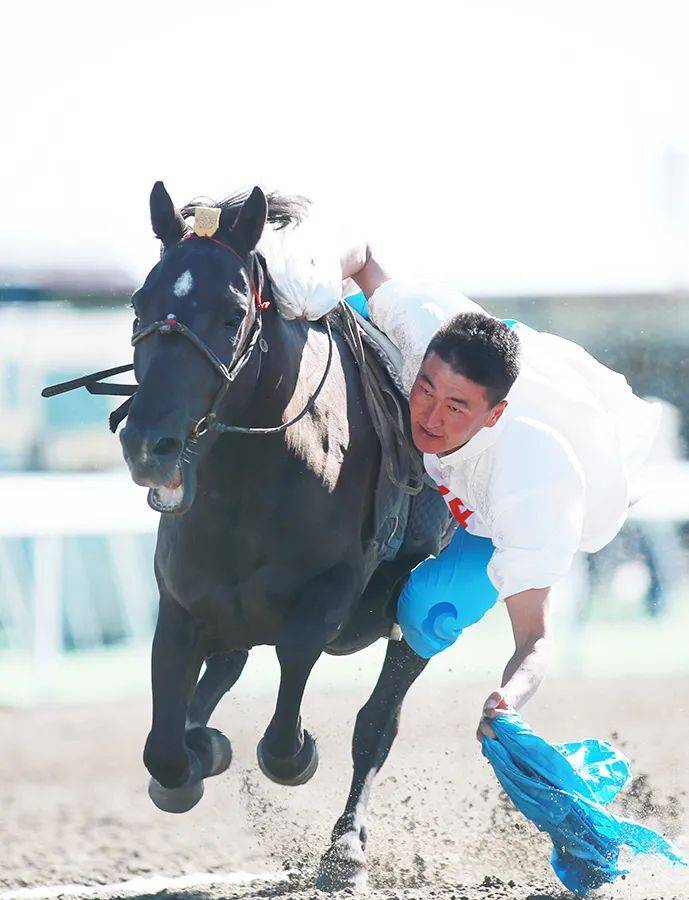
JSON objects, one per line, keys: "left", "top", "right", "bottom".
{"left": 0, "top": 594, "right": 689, "bottom": 707}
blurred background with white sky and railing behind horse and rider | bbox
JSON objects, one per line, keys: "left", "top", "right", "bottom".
{"left": 0, "top": 0, "right": 689, "bottom": 705}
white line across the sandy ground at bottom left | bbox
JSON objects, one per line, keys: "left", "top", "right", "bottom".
{"left": 0, "top": 872, "right": 290, "bottom": 900}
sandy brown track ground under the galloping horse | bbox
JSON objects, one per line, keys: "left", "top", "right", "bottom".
{"left": 0, "top": 678, "right": 689, "bottom": 900}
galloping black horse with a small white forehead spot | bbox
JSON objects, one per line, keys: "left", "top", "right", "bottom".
{"left": 116, "top": 182, "right": 446, "bottom": 887}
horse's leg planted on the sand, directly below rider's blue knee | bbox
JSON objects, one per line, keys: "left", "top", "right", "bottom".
{"left": 316, "top": 640, "right": 428, "bottom": 891}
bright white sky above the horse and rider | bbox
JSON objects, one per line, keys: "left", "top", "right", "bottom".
{"left": 0, "top": 0, "right": 689, "bottom": 293}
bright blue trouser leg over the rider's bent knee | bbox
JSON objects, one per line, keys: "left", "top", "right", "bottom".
{"left": 397, "top": 528, "right": 498, "bottom": 659}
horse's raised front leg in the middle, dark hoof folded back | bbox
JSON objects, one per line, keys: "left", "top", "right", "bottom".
{"left": 256, "top": 565, "right": 355, "bottom": 786}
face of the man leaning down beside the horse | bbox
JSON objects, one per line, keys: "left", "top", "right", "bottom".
{"left": 409, "top": 353, "right": 507, "bottom": 456}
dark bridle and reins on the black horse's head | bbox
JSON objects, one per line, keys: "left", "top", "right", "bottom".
{"left": 41, "top": 233, "right": 333, "bottom": 441}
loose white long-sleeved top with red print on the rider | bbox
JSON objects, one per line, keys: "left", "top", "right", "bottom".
{"left": 369, "top": 280, "right": 660, "bottom": 600}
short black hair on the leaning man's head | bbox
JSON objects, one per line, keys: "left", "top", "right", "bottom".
{"left": 426, "top": 312, "right": 519, "bottom": 406}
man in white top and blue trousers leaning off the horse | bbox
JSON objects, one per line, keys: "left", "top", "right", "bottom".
{"left": 260, "top": 223, "right": 660, "bottom": 740}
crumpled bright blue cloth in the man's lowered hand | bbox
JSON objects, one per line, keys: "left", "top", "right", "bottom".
{"left": 483, "top": 713, "right": 687, "bottom": 897}
